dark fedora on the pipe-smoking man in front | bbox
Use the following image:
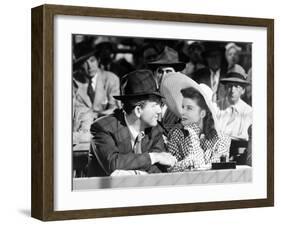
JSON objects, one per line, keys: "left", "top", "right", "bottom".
{"left": 114, "top": 69, "right": 162, "bottom": 101}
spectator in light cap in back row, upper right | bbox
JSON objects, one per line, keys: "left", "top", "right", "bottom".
{"left": 225, "top": 42, "right": 247, "bottom": 78}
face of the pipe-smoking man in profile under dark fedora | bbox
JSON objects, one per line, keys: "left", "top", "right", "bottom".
{"left": 140, "top": 101, "right": 161, "bottom": 128}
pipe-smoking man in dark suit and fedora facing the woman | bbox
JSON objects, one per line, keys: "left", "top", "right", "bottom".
{"left": 88, "top": 70, "right": 176, "bottom": 177}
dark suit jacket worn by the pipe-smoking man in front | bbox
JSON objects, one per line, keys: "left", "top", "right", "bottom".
{"left": 88, "top": 109, "right": 166, "bottom": 176}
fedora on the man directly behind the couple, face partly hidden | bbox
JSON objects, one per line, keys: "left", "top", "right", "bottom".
{"left": 147, "top": 46, "right": 185, "bottom": 71}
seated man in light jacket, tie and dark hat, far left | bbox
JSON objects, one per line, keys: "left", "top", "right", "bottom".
{"left": 73, "top": 38, "right": 120, "bottom": 143}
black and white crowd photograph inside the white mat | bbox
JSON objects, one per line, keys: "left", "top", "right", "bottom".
{"left": 70, "top": 34, "right": 253, "bottom": 190}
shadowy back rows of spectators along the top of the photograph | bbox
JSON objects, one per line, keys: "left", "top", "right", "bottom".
{"left": 72, "top": 35, "right": 252, "bottom": 92}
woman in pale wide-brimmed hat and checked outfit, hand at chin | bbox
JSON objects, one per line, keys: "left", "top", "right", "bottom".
{"left": 161, "top": 73, "right": 230, "bottom": 172}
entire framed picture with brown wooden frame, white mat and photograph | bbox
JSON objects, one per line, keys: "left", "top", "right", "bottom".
{"left": 31, "top": 5, "right": 274, "bottom": 221}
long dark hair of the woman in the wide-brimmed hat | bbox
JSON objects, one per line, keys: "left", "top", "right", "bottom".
{"left": 181, "top": 87, "right": 217, "bottom": 139}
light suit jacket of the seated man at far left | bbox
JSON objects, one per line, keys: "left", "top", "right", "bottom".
{"left": 73, "top": 70, "right": 120, "bottom": 132}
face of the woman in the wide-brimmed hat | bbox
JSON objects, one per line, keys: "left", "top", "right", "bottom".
{"left": 181, "top": 97, "right": 206, "bottom": 126}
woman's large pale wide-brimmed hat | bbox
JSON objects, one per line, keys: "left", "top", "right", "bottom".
{"left": 160, "top": 72, "right": 218, "bottom": 131}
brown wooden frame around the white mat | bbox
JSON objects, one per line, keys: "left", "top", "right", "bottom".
{"left": 31, "top": 5, "right": 274, "bottom": 221}
